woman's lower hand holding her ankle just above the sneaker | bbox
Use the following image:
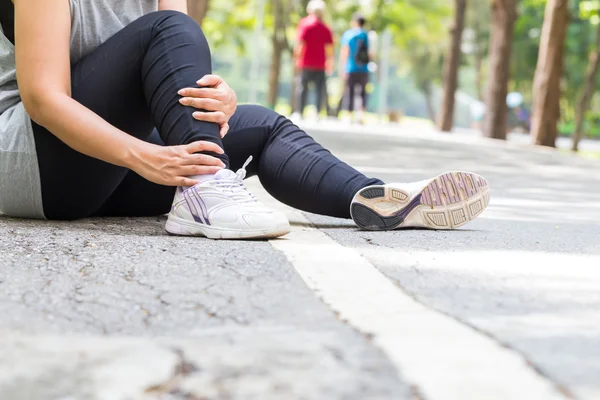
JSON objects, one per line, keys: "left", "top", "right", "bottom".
{"left": 127, "top": 141, "right": 225, "bottom": 186}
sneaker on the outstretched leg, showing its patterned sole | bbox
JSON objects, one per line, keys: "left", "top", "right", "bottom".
{"left": 350, "top": 172, "right": 490, "bottom": 231}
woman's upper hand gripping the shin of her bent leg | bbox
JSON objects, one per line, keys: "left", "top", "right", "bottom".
{"left": 178, "top": 75, "right": 237, "bottom": 138}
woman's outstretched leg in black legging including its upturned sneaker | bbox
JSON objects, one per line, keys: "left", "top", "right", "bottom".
{"left": 224, "top": 106, "right": 489, "bottom": 230}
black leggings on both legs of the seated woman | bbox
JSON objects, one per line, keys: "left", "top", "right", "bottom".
{"left": 34, "top": 11, "right": 381, "bottom": 220}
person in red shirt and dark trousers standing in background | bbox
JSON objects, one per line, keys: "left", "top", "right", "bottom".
{"left": 293, "top": 0, "right": 333, "bottom": 119}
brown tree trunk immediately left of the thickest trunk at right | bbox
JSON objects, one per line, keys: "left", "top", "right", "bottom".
{"left": 483, "top": 0, "right": 517, "bottom": 140}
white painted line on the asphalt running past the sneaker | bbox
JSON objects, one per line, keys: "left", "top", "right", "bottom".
{"left": 243, "top": 182, "right": 566, "bottom": 400}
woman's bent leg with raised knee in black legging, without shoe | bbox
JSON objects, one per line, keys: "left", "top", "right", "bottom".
{"left": 34, "top": 11, "right": 223, "bottom": 219}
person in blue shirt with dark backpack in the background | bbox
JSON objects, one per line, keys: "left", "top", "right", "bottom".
{"left": 339, "top": 14, "right": 372, "bottom": 123}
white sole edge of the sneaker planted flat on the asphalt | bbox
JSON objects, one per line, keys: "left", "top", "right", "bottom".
{"left": 165, "top": 215, "right": 290, "bottom": 239}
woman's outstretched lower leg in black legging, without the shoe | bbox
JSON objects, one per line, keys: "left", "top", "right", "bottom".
{"left": 223, "top": 105, "right": 383, "bottom": 218}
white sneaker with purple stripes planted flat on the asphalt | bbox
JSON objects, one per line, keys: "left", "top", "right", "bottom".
{"left": 165, "top": 157, "right": 290, "bottom": 239}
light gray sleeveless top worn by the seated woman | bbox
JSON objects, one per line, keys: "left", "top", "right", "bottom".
{"left": 0, "top": 0, "right": 158, "bottom": 219}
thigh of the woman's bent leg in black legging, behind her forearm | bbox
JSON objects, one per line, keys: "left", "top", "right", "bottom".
{"left": 34, "top": 13, "right": 183, "bottom": 219}
